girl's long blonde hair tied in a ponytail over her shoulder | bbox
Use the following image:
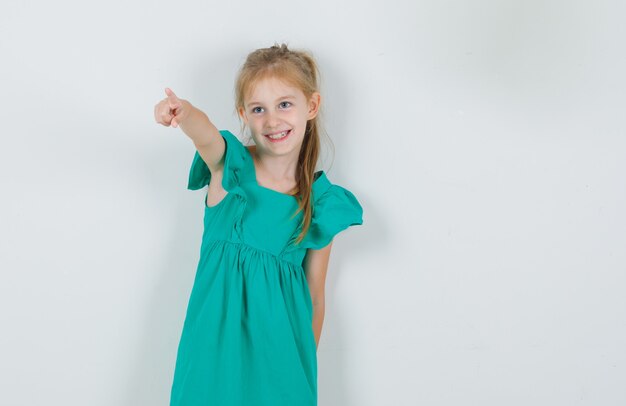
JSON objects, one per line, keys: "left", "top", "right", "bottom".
{"left": 235, "top": 43, "right": 320, "bottom": 244}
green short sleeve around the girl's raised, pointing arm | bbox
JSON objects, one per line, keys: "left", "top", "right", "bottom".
{"left": 187, "top": 130, "right": 248, "bottom": 191}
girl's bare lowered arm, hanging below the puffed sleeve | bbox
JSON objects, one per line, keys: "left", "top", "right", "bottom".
{"left": 304, "top": 241, "right": 333, "bottom": 348}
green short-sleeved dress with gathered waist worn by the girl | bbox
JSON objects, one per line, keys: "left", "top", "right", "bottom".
{"left": 170, "top": 131, "right": 363, "bottom": 406}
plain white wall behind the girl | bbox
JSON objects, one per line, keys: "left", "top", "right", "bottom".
{"left": 0, "top": 0, "right": 626, "bottom": 406}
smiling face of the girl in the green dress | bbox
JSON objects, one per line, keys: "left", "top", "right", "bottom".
{"left": 239, "top": 78, "right": 320, "bottom": 156}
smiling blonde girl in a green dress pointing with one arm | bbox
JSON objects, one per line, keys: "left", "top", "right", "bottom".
{"left": 155, "top": 44, "right": 363, "bottom": 406}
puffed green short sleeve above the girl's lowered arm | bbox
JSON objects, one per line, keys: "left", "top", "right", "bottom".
{"left": 300, "top": 184, "right": 363, "bottom": 249}
